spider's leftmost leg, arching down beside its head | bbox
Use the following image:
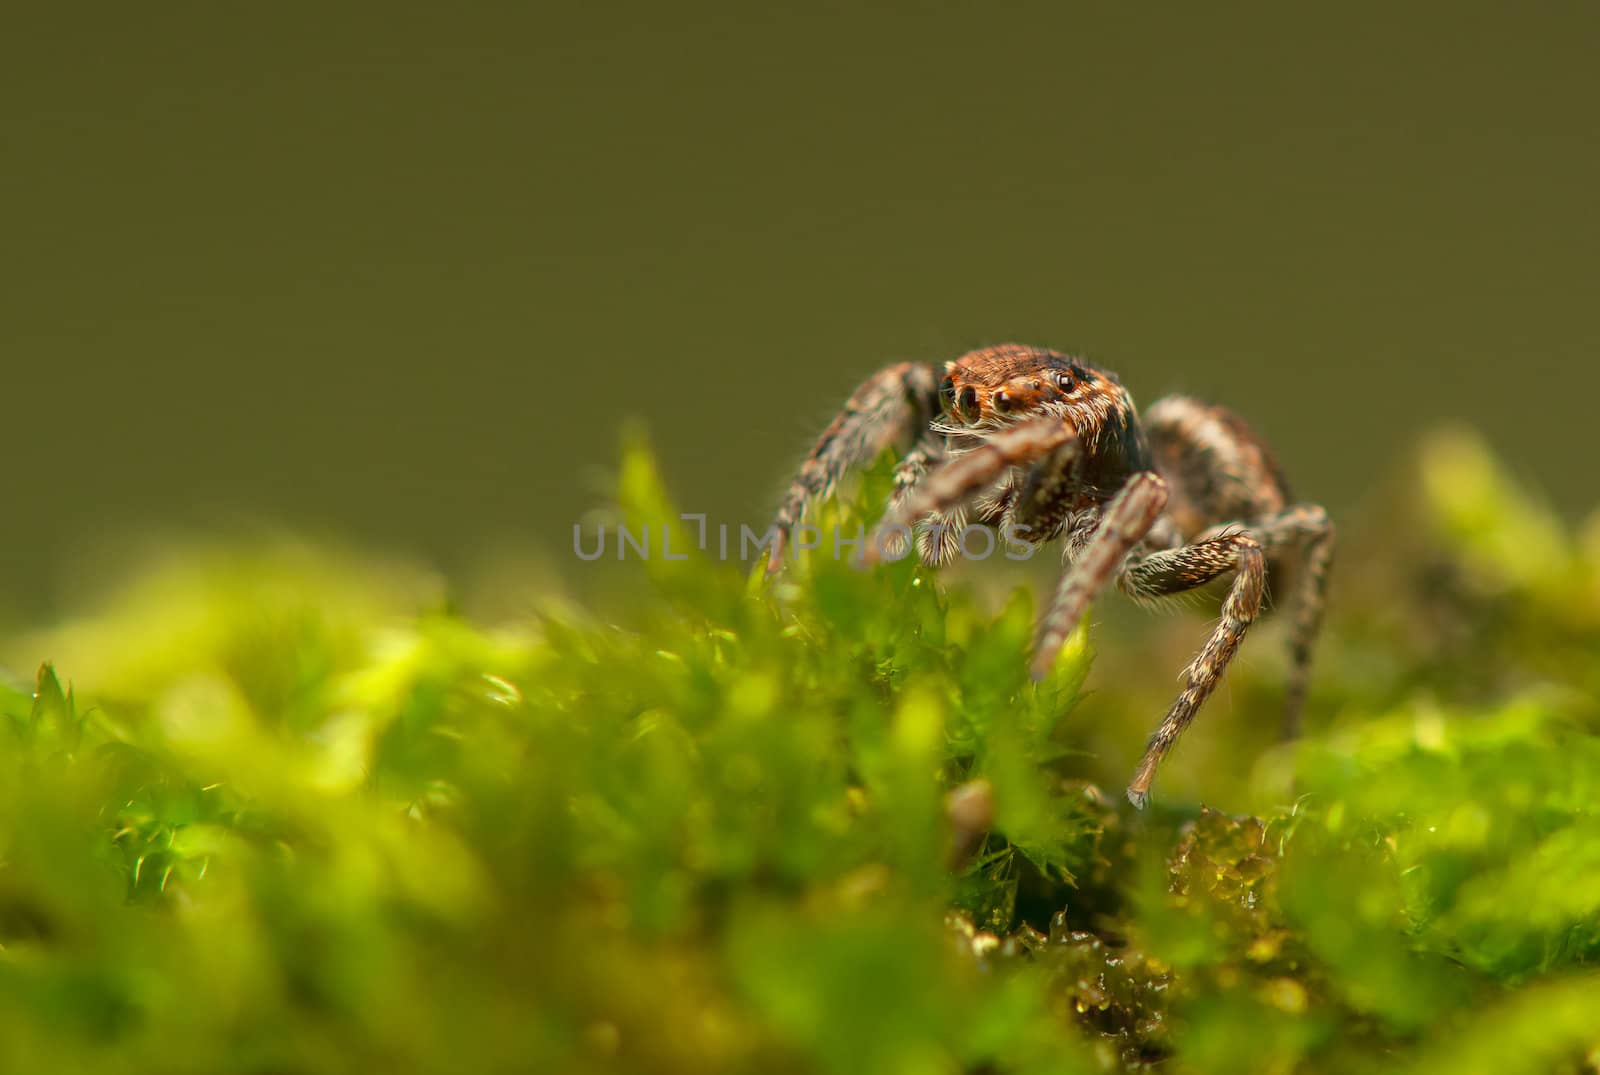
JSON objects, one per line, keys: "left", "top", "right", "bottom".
{"left": 766, "top": 362, "right": 939, "bottom": 574}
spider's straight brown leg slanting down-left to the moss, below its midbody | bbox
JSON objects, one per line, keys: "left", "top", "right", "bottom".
{"left": 1030, "top": 470, "right": 1166, "bottom": 680}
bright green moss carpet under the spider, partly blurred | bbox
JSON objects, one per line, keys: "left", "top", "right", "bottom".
{"left": 0, "top": 435, "right": 1600, "bottom": 1073}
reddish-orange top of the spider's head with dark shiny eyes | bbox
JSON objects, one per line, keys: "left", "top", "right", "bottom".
{"left": 938, "top": 344, "right": 1134, "bottom": 445}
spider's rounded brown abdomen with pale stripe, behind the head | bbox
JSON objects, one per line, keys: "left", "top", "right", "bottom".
{"left": 1144, "top": 395, "right": 1291, "bottom": 541}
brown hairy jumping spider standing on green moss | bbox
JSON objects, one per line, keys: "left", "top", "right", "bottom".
{"left": 768, "top": 344, "right": 1333, "bottom": 808}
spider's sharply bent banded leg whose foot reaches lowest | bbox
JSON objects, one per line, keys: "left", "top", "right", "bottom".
{"left": 1122, "top": 533, "right": 1267, "bottom": 809}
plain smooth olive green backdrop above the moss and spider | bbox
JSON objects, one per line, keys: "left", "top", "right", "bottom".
{"left": 0, "top": 3, "right": 1600, "bottom": 613}
